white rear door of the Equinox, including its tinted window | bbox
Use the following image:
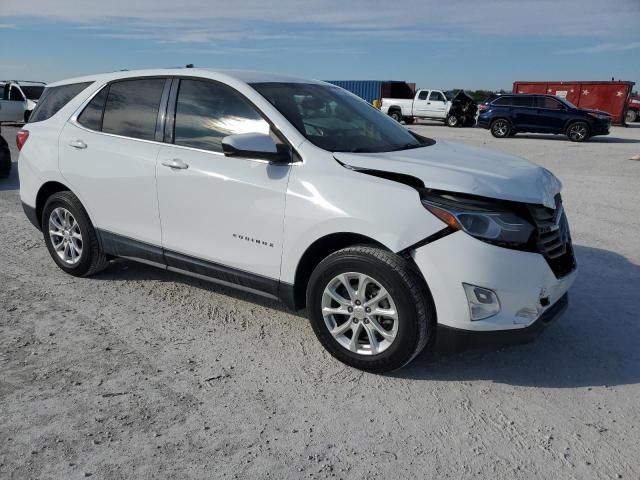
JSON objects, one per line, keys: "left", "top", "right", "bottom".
{"left": 59, "top": 78, "right": 168, "bottom": 248}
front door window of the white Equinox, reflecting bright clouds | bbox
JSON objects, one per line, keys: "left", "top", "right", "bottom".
{"left": 174, "top": 80, "right": 270, "bottom": 152}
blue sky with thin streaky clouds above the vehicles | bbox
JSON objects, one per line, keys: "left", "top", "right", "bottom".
{"left": 0, "top": 0, "right": 640, "bottom": 90}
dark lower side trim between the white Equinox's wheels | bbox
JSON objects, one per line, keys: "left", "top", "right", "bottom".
{"left": 98, "top": 230, "right": 293, "bottom": 308}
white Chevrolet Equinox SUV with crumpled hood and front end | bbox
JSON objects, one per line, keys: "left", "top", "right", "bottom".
{"left": 17, "top": 69, "right": 576, "bottom": 372}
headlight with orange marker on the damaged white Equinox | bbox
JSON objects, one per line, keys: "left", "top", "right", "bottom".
{"left": 422, "top": 192, "right": 534, "bottom": 246}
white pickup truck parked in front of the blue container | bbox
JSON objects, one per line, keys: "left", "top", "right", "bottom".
{"left": 380, "top": 89, "right": 451, "bottom": 123}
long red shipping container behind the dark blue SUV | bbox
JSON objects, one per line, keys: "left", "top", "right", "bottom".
{"left": 513, "top": 81, "right": 635, "bottom": 125}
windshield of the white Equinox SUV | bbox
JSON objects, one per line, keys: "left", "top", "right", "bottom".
{"left": 251, "top": 82, "right": 428, "bottom": 152}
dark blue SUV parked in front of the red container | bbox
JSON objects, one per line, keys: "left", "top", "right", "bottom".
{"left": 478, "top": 94, "right": 611, "bottom": 142}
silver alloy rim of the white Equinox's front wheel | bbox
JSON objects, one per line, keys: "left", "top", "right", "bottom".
{"left": 322, "top": 272, "right": 398, "bottom": 355}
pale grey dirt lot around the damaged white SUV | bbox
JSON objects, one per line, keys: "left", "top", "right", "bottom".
{"left": 0, "top": 124, "right": 640, "bottom": 479}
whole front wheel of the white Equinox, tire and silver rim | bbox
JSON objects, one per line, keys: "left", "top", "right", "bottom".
{"left": 307, "top": 246, "right": 436, "bottom": 373}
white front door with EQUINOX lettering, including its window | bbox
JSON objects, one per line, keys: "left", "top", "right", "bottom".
{"left": 157, "top": 79, "right": 292, "bottom": 286}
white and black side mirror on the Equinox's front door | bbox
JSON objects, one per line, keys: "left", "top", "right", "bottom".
{"left": 222, "top": 133, "right": 293, "bottom": 163}
